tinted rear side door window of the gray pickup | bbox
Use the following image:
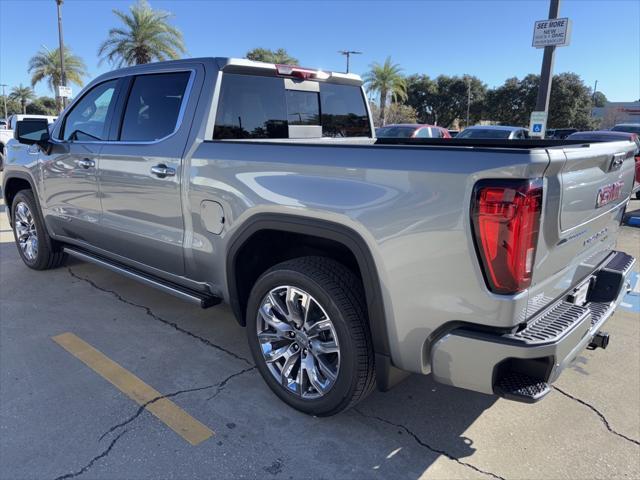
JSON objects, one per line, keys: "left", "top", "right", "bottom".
{"left": 120, "top": 72, "right": 191, "bottom": 142}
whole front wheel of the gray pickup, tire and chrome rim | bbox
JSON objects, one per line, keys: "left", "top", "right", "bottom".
{"left": 11, "top": 190, "right": 65, "bottom": 270}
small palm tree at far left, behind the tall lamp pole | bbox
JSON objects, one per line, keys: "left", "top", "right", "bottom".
{"left": 28, "top": 47, "right": 88, "bottom": 110}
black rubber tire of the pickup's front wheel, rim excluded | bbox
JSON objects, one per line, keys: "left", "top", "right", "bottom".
{"left": 11, "top": 190, "right": 66, "bottom": 270}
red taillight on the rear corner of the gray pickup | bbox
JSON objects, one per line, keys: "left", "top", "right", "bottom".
{"left": 471, "top": 179, "right": 542, "bottom": 294}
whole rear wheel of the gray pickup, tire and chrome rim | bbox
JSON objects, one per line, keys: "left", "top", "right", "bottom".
{"left": 247, "top": 257, "right": 375, "bottom": 416}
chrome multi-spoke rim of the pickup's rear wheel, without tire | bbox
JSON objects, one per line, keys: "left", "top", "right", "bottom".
{"left": 256, "top": 285, "right": 340, "bottom": 399}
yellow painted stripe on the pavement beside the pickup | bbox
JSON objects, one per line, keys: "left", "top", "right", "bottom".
{"left": 52, "top": 333, "right": 213, "bottom": 445}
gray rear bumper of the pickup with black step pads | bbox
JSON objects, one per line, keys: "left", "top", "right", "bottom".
{"left": 431, "top": 252, "right": 635, "bottom": 394}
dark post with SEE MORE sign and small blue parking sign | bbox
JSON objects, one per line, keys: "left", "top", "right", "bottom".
{"left": 529, "top": 0, "right": 571, "bottom": 138}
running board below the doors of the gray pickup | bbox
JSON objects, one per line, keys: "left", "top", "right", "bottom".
{"left": 64, "top": 247, "right": 222, "bottom": 308}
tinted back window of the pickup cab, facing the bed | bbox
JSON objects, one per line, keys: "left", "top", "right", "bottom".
{"left": 213, "top": 73, "right": 371, "bottom": 140}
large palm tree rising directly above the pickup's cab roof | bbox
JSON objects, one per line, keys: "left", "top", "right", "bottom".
{"left": 98, "top": 0, "right": 186, "bottom": 67}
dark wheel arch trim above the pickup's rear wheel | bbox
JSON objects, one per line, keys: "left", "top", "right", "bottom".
{"left": 226, "top": 213, "right": 389, "bottom": 357}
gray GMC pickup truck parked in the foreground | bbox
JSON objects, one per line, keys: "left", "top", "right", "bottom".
{"left": 3, "top": 58, "right": 636, "bottom": 415}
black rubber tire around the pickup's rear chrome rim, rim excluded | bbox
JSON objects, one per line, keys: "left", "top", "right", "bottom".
{"left": 246, "top": 257, "right": 375, "bottom": 416}
